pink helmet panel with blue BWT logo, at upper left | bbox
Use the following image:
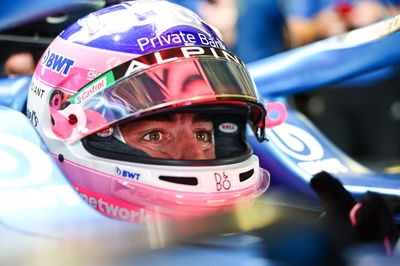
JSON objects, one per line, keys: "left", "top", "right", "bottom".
{"left": 34, "top": 37, "right": 135, "bottom": 94}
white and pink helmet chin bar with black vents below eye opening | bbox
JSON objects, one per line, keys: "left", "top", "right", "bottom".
{"left": 62, "top": 151, "right": 270, "bottom": 219}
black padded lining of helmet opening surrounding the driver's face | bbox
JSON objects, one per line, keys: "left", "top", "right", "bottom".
{"left": 82, "top": 104, "right": 253, "bottom": 166}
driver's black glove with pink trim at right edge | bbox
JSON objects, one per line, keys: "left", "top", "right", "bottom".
{"left": 311, "top": 172, "right": 400, "bottom": 254}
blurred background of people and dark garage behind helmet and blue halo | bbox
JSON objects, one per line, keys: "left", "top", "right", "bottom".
{"left": 0, "top": 0, "right": 400, "bottom": 169}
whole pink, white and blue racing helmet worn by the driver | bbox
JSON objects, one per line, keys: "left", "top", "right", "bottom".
{"left": 27, "top": 0, "right": 269, "bottom": 223}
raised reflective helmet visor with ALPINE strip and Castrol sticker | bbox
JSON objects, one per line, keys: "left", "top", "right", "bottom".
{"left": 52, "top": 47, "right": 265, "bottom": 141}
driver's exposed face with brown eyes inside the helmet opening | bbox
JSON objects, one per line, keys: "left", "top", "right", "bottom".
{"left": 120, "top": 113, "right": 215, "bottom": 160}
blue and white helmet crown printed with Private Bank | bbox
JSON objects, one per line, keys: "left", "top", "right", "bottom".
{"left": 60, "top": 0, "right": 226, "bottom": 54}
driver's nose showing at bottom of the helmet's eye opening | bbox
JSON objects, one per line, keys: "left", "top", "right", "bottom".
{"left": 173, "top": 133, "right": 207, "bottom": 160}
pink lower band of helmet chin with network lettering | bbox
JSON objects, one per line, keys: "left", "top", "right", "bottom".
{"left": 60, "top": 156, "right": 269, "bottom": 221}
